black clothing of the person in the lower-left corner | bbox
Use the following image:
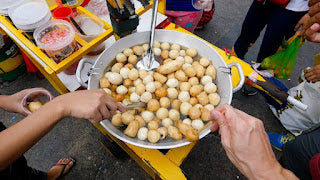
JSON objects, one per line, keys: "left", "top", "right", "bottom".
{"left": 0, "top": 122, "right": 47, "bottom": 180}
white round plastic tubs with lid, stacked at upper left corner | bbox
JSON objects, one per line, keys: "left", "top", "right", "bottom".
{"left": 9, "top": 0, "right": 51, "bottom": 32}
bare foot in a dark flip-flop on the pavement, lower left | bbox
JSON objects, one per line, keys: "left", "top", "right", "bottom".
{"left": 47, "top": 158, "right": 75, "bottom": 180}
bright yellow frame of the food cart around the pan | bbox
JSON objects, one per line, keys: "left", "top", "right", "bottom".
{"left": 0, "top": 1, "right": 262, "bottom": 180}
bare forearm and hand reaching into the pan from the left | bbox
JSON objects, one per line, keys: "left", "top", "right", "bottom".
{"left": 0, "top": 90, "right": 124, "bottom": 171}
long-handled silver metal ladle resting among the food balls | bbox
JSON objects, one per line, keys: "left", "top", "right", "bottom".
{"left": 137, "top": 0, "right": 160, "bottom": 71}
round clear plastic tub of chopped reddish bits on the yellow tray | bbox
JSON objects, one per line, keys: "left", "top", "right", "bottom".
{"left": 33, "top": 19, "right": 75, "bottom": 50}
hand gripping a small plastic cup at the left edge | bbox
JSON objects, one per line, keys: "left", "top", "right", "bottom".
{"left": 3, "top": 88, "right": 52, "bottom": 116}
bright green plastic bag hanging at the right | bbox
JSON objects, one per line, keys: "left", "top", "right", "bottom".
{"left": 261, "top": 36, "right": 304, "bottom": 79}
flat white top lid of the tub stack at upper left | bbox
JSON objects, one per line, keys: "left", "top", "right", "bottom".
{"left": 9, "top": 1, "right": 50, "bottom": 26}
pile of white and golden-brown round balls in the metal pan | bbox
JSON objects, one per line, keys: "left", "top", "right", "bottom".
{"left": 100, "top": 41, "right": 220, "bottom": 143}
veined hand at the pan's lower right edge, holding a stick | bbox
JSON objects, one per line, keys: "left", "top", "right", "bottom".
{"left": 210, "top": 105, "right": 283, "bottom": 179}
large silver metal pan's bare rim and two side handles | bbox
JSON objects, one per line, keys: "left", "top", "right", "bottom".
{"left": 77, "top": 29, "right": 244, "bottom": 149}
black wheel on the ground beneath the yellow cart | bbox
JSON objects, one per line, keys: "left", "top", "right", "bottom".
{"left": 99, "top": 137, "right": 129, "bottom": 160}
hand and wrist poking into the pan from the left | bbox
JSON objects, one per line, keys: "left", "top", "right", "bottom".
{"left": 52, "top": 89, "right": 125, "bottom": 123}
